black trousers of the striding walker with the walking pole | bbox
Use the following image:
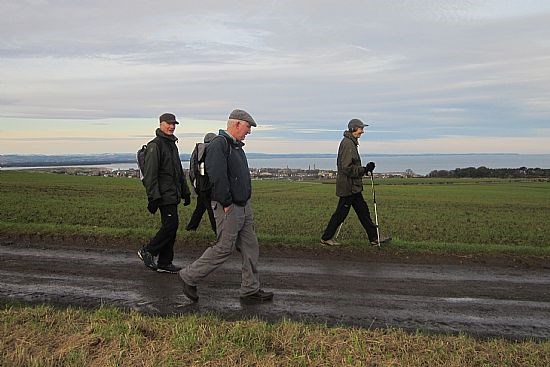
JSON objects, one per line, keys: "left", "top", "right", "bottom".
{"left": 321, "top": 192, "right": 377, "bottom": 241}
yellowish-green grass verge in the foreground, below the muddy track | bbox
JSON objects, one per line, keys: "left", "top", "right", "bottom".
{"left": 0, "top": 303, "right": 550, "bottom": 367}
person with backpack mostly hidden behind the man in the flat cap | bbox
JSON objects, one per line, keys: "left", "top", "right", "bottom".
{"left": 185, "top": 133, "right": 217, "bottom": 233}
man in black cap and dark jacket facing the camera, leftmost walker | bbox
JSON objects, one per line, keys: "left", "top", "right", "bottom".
{"left": 138, "top": 113, "right": 191, "bottom": 273}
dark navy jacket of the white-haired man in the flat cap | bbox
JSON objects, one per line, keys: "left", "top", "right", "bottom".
{"left": 205, "top": 130, "right": 252, "bottom": 207}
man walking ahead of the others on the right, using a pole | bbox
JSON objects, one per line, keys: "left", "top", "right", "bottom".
{"left": 321, "top": 119, "right": 386, "bottom": 246}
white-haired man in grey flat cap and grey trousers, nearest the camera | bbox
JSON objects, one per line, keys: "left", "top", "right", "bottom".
{"left": 179, "top": 110, "right": 273, "bottom": 302}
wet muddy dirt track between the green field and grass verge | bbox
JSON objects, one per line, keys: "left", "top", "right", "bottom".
{"left": 0, "top": 241, "right": 550, "bottom": 339}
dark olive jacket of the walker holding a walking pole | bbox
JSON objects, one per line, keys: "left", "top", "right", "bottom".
{"left": 336, "top": 131, "right": 366, "bottom": 197}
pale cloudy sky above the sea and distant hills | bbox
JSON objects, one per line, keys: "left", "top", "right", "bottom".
{"left": 0, "top": 0, "right": 550, "bottom": 154}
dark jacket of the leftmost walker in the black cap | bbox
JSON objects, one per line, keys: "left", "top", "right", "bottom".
{"left": 143, "top": 129, "right": 190, "bottom": 205}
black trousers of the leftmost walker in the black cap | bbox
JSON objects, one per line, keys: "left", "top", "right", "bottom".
{"left": 145, "top": 204, "right": 179, "bottom": 266}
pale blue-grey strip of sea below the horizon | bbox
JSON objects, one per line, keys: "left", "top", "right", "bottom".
{"left": 2, "top": 154, "right": 550, "bottom": 175}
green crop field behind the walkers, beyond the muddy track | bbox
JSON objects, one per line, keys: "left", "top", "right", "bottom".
{"left": 0, "top": 171, "right": 550, "bottom": 256}
